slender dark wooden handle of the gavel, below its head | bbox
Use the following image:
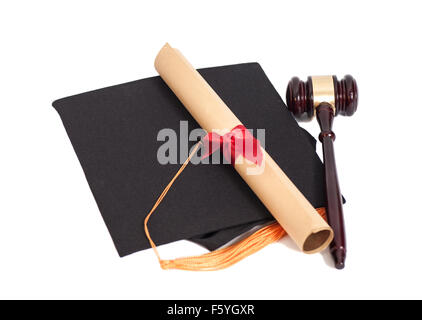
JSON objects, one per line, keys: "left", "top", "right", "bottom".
{"left": 316, "top": 103, "right": 346, "bottom": 269}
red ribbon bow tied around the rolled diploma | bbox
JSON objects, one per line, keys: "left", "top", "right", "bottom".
{"left": 202, "top": 124, "right": 263, "bottom": 165}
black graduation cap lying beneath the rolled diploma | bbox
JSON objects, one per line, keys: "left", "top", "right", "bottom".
{"left": 53, "top": 63, "right": 325, "bottom": 256}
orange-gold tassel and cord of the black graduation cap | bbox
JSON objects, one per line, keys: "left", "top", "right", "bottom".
{"left": 144, "top": 141, "right": 326, "bottom": 271}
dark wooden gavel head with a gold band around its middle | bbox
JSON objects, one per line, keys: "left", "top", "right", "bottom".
{"left": 286, "top": 75, "right": 358, "bottom": 121}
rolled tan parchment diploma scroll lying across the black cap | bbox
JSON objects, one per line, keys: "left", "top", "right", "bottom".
{"left": 154, "top": 44, "right": 333, "bottom": 253}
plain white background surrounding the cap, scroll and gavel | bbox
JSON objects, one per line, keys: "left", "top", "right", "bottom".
{"left": 0, "top": 0, "right": 422, "bottom": 299}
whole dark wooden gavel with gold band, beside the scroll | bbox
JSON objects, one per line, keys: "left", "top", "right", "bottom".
{"left": 286, "top": 75, "right": 358, "bottom": 269}
